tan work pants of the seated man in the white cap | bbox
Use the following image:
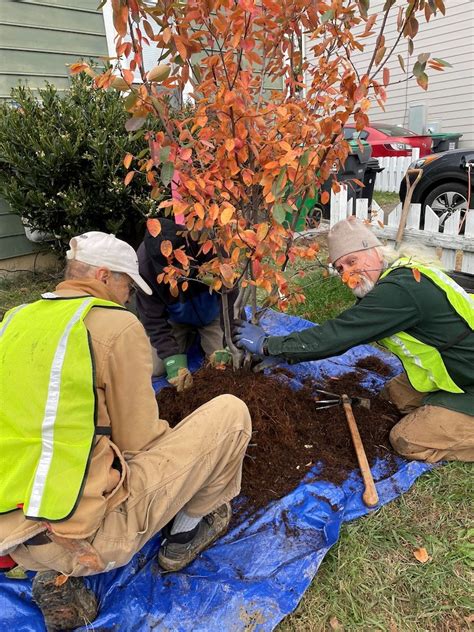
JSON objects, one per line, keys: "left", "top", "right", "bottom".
{"left": 12, "top": 395, "right": 251, "bottom": 576}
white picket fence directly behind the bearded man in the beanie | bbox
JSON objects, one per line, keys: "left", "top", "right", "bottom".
{"left": 329, "top": 186, "right": 474, "bottom": 274}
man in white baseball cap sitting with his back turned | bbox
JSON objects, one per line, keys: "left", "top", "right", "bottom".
{"left": 0, "top": 231, "right": 251, "bottom": 631}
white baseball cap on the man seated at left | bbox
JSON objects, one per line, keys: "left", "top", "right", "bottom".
{"left": 66, "top": 230, "right": 153, "bottom": 294}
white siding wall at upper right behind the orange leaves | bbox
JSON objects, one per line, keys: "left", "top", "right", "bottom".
{"left": 306, "top": 0, "right": 474, "bottom": 147}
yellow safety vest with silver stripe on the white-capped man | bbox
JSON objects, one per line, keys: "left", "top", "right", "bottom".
{"left": 0, "top": 295, "right": 124, "bottom": 521}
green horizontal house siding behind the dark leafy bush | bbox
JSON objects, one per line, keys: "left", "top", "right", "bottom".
{"left": 0, "top": 0, "right": 108, "bottom": 260}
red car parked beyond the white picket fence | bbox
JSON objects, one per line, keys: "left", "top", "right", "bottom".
{"left": 344, "top": 123, "right": 433, "bottom": 158}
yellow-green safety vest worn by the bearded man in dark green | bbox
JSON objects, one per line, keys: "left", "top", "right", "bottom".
{"left": 378, "top": 258, "right": 474, "bottom": 393}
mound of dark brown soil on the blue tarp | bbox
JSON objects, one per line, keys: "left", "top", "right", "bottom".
{"left": 157, "top": 357, "right": 400, "bottom": 511}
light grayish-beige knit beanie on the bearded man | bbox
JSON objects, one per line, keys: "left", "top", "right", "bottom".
{"left": 328, "top": 215, "right": 382, "bottom": 263}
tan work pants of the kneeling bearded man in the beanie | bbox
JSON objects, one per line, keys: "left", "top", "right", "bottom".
{"left": 381, "top": 373, "right": 474, "bottom": 463}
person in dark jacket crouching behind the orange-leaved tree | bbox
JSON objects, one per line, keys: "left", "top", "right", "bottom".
{"left": 136, "top": 218, "right": 230, "bottom": 391}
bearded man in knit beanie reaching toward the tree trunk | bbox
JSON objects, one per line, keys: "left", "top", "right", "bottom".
{"left": 235, "top": 218, "right": 474, "bottom": 463}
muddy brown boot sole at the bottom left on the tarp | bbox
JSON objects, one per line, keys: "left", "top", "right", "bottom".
{"left": 33, "top": 571, "right": 98, "bottom": 632}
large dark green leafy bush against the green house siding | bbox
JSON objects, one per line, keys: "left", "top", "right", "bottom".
{"left": 0, "top": 75, "right": 160, "bottom": 250}
